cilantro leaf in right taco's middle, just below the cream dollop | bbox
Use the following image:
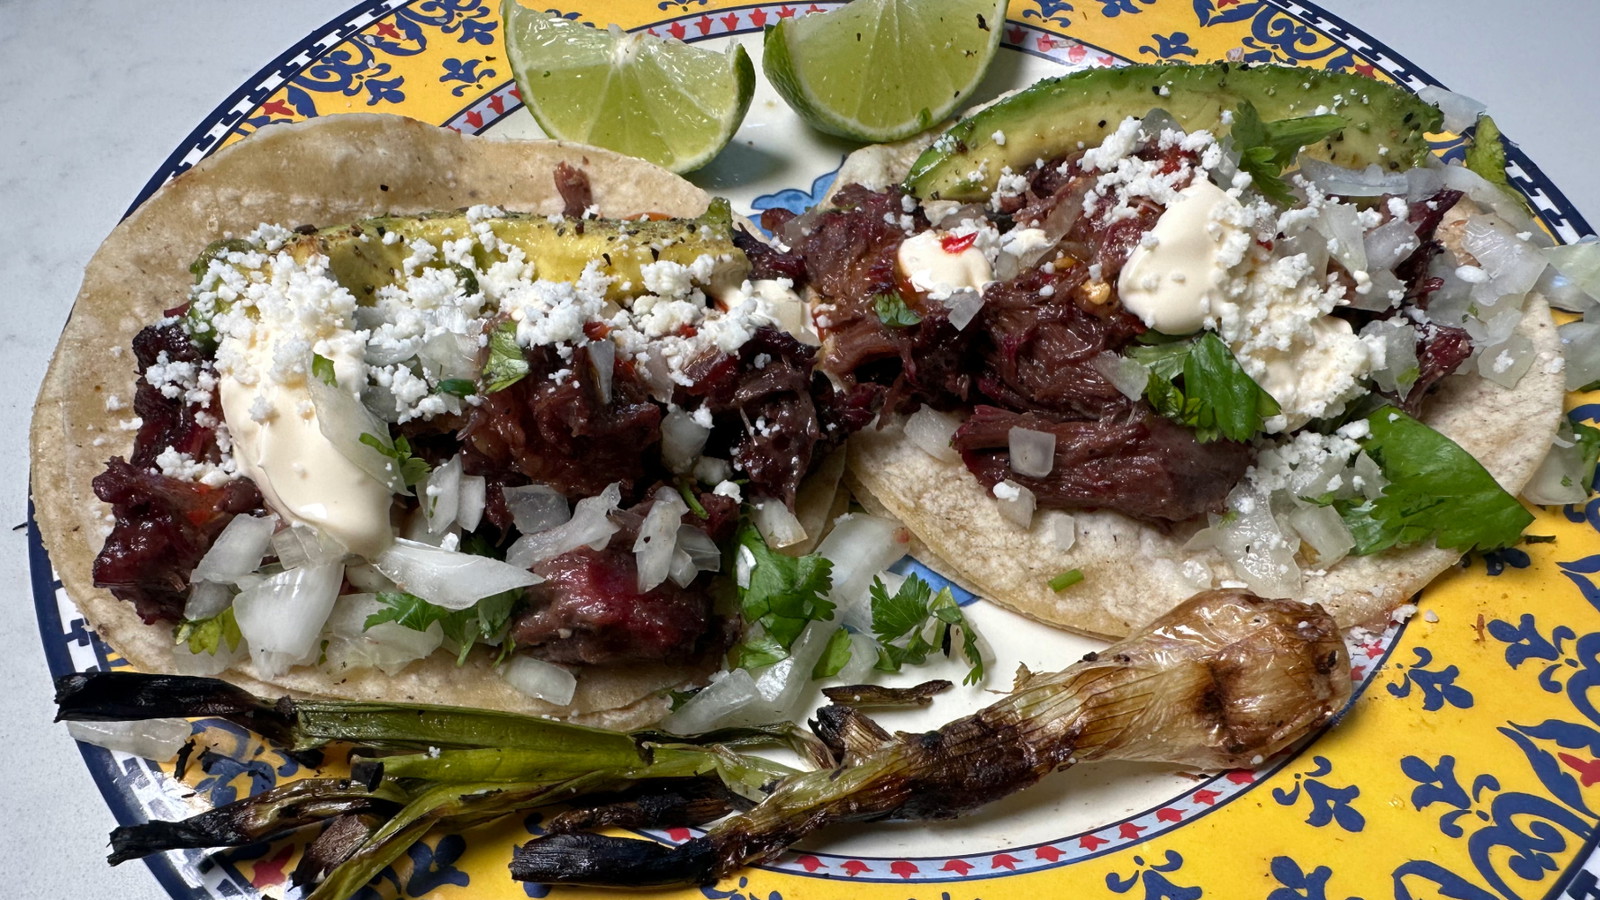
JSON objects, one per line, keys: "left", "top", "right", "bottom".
{"left": 1126, "top": 331, "right": 1280, "bottom": 440}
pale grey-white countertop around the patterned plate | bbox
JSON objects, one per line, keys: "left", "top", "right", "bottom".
{"left": 0, "top": 0, "right": 1600, "bottom": 900}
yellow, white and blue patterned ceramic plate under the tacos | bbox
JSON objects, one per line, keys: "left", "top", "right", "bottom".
{"left": 32, "top": 0, "right": 1600, "bottom": 900}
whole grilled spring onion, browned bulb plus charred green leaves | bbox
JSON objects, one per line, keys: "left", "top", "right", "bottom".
{"left": 56, "top": 591, "right": 1350, "bottom": 883}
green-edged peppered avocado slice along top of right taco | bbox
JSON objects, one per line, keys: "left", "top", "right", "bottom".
{"left": 906, "top": 62, "right": 1443, "bottom": 202}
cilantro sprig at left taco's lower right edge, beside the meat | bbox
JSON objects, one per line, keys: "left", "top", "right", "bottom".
{"left": 733, "top": 522, "right": 834, "bottom": 663}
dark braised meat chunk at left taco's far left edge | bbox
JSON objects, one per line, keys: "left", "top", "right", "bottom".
{"left": 93, "top": 456, "right": 261, "bottom": 625}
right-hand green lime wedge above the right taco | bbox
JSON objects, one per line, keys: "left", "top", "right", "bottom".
{"left": 762, "top": 0, "right": 1006, "bottom": 141}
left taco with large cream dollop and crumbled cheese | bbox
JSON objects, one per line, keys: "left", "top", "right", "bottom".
{"left": 32, "top": 115, "right": 862, "bottom": 727}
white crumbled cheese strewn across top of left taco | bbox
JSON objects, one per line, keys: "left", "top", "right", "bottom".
{"left": 157, "top": 207, "right": 794, "bottom": 484}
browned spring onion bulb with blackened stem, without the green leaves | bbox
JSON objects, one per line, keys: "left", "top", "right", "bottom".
{"left": 510, "top": 591, "right": 1350, "bottom": 887}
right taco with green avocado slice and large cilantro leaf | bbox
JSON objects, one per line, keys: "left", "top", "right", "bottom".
{"left": 766, "top": 66, "right": 1563, "bottom": 637}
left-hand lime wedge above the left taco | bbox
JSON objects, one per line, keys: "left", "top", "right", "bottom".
{"left": 504, "top": 0, "right": 755, "bottom": 171}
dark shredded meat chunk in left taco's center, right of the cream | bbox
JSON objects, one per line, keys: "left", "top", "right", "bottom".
{"left": 461, "top": 337, "right": 661, "bottom": 509}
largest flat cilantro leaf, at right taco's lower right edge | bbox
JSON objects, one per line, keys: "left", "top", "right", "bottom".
{"left": 1334, "top": 407, "right": 1533, "bottom": 556}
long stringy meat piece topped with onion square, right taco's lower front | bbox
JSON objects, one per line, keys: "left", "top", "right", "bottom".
{"left": 952, "top": 407, "right": 1251, "bottom": 522}
